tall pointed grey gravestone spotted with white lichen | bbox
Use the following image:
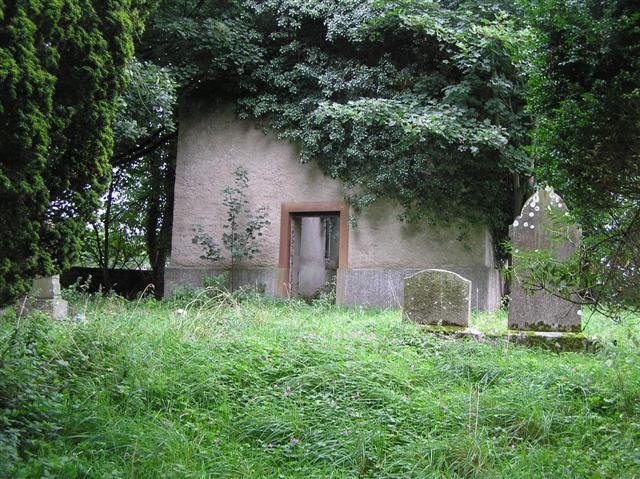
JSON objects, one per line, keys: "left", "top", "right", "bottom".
{"left": 508, "top": 187, "right": 582, "bottom": 331}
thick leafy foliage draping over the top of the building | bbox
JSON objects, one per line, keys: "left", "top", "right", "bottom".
{"left": 239, "top": 0, "right": 532, "bottom": 238}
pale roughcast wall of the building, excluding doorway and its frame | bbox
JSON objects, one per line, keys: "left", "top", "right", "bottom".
{"left": 165, "top": 103, "right": 500, "bottom": 309}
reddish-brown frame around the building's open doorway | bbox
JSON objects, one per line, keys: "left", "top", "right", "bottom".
{"left": 276, "top": 201, "right": 349, "bottom": 298}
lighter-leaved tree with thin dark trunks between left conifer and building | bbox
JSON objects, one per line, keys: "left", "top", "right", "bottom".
{"left": 90, "top": 59, "right": 177, "bottom": 297}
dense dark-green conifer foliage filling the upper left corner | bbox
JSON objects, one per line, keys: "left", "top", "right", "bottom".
{"left": 0, "top": 0, "right": 145, "bottom": 303}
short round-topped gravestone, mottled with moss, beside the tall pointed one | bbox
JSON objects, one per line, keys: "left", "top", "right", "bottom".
{"left": 404, "top": 269, "right": 471, "bottom": 328}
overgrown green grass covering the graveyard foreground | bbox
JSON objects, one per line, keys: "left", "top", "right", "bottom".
{"left": 0, "top": 296, "right": 640, "bottom": 478}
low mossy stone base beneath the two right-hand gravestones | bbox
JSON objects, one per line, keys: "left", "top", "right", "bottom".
{"left": 421, "top": 324, "right": 598, "bottom": 352}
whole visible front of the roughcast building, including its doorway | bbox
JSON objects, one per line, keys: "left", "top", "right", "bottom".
{"left": 165, "top": 102, "right": 501, "bottom": 310}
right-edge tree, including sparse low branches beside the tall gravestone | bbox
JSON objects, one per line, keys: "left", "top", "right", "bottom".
{"left": 527, "top": 0, "right": 640, "bottom": 315}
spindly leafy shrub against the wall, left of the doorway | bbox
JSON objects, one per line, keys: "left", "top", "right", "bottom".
{"left": 193, "top": 166, "right": 271, "bottom": 289}
